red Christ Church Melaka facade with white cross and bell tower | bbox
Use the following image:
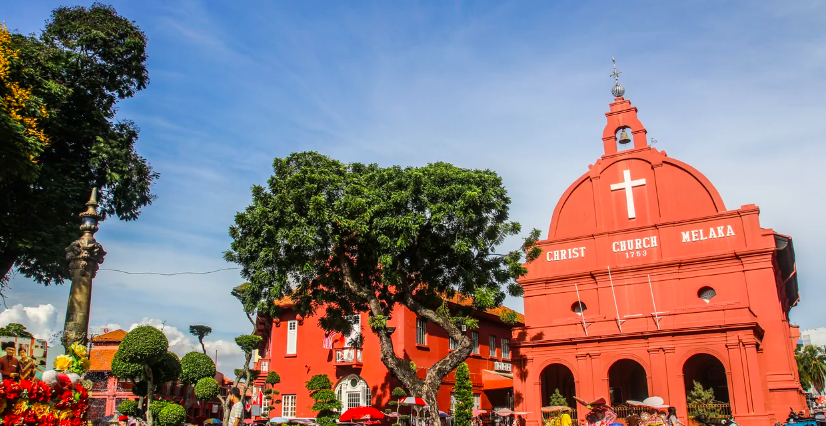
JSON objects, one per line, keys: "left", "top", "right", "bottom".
{"left": 513, "top": 88, "right": 806, "bottom": 426}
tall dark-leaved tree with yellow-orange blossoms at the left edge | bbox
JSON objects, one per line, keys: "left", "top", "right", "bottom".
{"left": 0, "top": 3, "right": 158, "bottom": 289}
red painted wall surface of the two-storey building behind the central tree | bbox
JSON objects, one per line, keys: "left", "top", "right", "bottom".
{"left": 256, "top": 306, "right": 513, "bottom": 417}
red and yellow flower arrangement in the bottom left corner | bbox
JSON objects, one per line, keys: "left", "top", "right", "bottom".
{"left": 0, "top": 343, "right": 89, "bottom": 426}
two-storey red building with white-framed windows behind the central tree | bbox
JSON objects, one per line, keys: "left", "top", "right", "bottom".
{"left": 255, "top": 301, "right": 522, "bottom": 418}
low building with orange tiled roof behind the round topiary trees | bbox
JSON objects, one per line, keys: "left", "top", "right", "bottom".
{"left": 87, "top": 330, "right": 232, "bottom": 424}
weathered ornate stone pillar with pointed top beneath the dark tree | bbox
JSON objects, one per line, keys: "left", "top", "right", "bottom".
{"left": 61, "top": 188, "right": 106, "bottom": 351}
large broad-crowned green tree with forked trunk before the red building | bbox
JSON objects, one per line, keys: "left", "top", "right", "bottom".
{"left": 225, "top": 152, "right": 539, "bottom": 420}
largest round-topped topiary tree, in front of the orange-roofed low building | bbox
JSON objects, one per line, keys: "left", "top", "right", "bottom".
{"left": 112, "top": 325, "right": 183, "bottom": 426}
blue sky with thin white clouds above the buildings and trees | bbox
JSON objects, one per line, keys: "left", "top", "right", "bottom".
{"left": 0, "top": 0, "right": 826, "bottom": 370}
